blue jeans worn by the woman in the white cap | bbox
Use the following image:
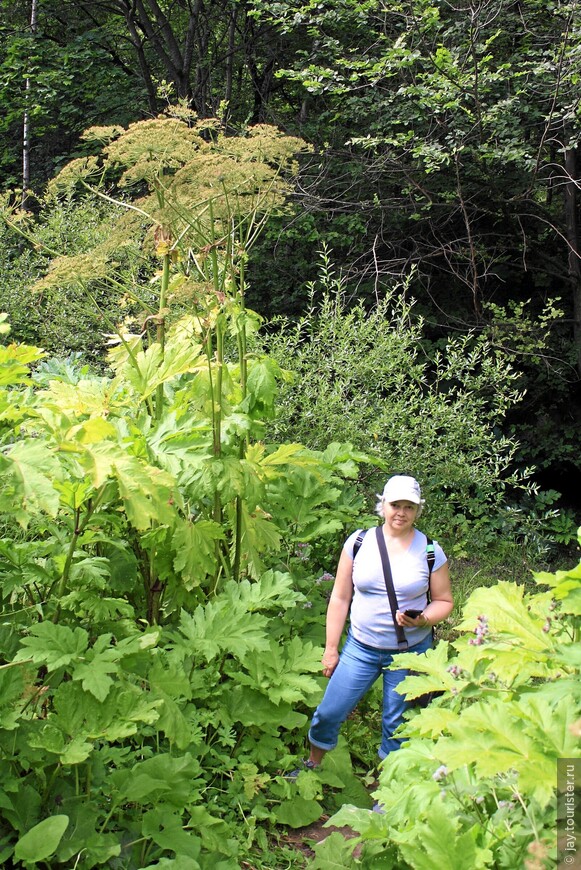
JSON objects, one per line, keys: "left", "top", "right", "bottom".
{"left": 309, "top": 632, "right": 432, "bottom": 759}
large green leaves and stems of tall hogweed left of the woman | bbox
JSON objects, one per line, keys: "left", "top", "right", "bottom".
{"left": 0, "top": 150, "right": 364, "bottom": 870}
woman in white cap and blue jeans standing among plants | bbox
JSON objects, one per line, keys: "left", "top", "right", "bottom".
{"left": 305, "top": 475, "right": 454, "bottom": 768}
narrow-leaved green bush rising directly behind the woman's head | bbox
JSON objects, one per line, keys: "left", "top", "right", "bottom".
{"left": 258, "top": 252, "right": 528, "bottom": 556}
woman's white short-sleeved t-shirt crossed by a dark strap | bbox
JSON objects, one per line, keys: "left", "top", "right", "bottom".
{"left": 344, "top": 528, "right": 447, "bottom": 649}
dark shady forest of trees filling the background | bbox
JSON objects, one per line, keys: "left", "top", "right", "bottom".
{"left": 0, "top": 0, "right": 581, "bottom": 524}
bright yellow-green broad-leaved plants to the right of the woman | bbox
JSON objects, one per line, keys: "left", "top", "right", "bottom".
{"left": 309, "top": 530, "right": 581, "bottom": 870}
